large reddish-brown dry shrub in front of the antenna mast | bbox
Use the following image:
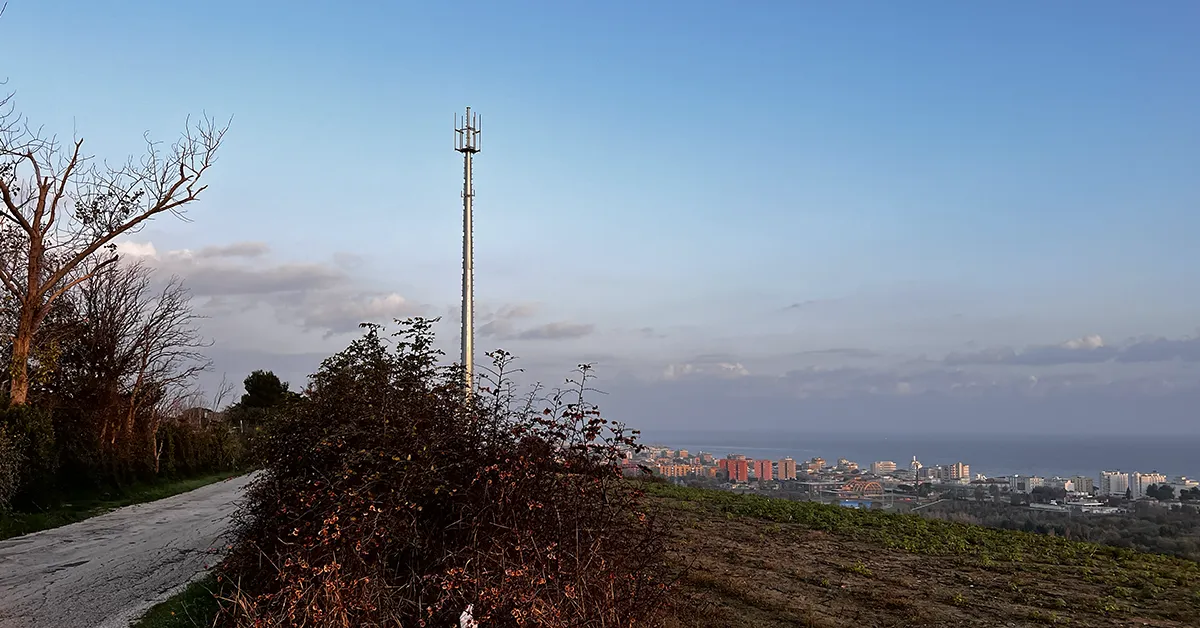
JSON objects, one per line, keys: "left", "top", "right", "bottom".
{"left": 220, "top": 318, "right": 667, "bottom": 628}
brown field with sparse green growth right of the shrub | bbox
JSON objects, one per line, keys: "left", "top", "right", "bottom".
{"left": 648, "top": 484, "right": 1200, "bottom": 627}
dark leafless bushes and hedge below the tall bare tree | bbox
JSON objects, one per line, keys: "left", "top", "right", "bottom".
{"left": 0, "top": 264, "right": 245, "bottom": 513}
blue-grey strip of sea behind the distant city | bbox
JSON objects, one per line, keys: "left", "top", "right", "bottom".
{"left": 641, "top": 427, "right": 1200, "bottom": 479}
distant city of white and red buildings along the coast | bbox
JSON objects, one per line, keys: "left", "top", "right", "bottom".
{"left": 624, "top": 445, "right": 1200, "bottom": 514}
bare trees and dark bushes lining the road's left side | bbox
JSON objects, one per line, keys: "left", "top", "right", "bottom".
{"left": 0, "top": 90, "right": 245, "bottom": 518}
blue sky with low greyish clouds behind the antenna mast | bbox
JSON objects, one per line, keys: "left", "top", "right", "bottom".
{"left": 0, "top": 0, "right": 1200, "bottom": 435}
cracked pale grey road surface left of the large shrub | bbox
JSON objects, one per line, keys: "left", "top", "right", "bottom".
{"left": 0, "top": 476, "right": 251, "bottom": 628}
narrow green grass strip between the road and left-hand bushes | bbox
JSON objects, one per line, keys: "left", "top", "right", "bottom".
{"left": 0, "top": 472, "right": 241, "bottom": 540}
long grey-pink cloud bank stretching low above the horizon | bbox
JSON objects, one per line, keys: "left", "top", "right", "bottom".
{"left": 118, "top": 241, "right": 1200, "bottom": 431}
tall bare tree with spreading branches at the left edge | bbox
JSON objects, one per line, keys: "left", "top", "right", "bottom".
{"left": 0, "top": 99, "right": 228, "bottom": 405}
